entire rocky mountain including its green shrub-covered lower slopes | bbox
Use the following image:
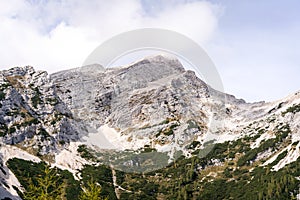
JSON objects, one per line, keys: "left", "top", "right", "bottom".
{"left": 0, "top": 55, "right": 300, "bottom": 199}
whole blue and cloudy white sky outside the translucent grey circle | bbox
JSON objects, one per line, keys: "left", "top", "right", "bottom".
{"left": 0, "top": 0, "right": 300, "bottom": 102}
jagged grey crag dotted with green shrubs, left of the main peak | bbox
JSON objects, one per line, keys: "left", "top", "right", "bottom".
{"left": 0, "top": 67, "right": 83, "bottom": 154}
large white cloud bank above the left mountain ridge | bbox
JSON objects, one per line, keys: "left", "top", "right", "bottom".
{"left": 0, "top": 0, "right": 218, "bottom": 72}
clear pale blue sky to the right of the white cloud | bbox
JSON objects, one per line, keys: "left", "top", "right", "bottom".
{"left": 207, "top": 0, "right": 300, "bottom": 101}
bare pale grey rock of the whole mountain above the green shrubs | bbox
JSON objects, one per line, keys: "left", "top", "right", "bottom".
{"left": 0, "top": 56, "right": 300, "bottom": 200}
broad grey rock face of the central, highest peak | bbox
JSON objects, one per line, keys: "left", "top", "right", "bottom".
{"left": 50, "top": 56, "right": 225, "bottom": 151}
